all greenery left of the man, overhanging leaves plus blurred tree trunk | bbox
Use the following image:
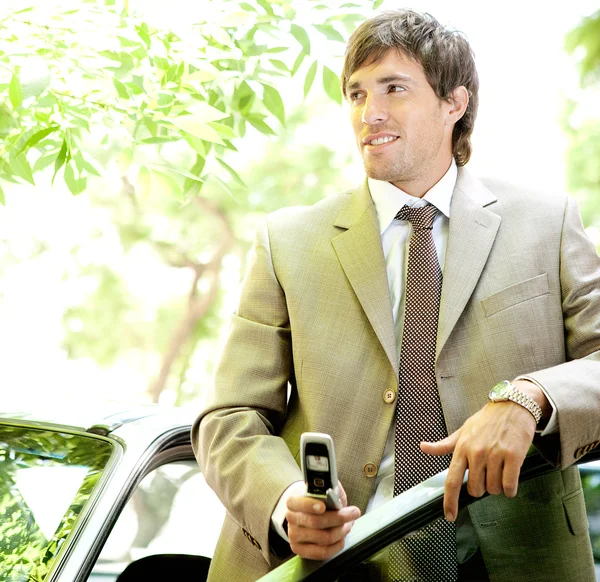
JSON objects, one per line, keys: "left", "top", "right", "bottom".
{"left": 0, "top": 0, "right": 381, "bottom": 403}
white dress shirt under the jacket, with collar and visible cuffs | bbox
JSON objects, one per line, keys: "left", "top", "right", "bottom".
{"left": 271, "top": 159, "right": 558, "bottom": 540}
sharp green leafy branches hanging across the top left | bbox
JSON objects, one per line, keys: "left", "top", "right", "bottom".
{"left": 0, "top": 0, "right": 373, "bottom": 204}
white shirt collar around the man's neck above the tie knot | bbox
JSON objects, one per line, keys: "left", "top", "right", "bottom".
{"left": 367, "top": 158, "right": 458, "bottom": 234}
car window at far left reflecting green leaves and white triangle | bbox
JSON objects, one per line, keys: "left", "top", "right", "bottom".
{"left": 0, "top": 426, "right": 113, "bottom": 582}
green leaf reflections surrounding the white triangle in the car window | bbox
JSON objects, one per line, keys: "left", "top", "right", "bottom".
{"left": 0, "top": 427, "right": 112, "bottom": 582}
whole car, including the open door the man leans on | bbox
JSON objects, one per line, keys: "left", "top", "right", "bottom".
{"left": 0, "top": 402, "right": 600, "bottom": 582}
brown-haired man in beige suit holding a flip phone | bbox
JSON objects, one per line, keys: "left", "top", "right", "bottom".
{"left": 193, "top": 10, "right": 600, "bottom": 581}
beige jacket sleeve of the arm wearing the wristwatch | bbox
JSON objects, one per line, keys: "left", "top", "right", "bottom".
{"left": 528, "top": 198, "right": 600, "bottom": 469}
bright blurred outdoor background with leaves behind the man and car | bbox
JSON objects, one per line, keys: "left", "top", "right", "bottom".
{"left": 0, "top": 0, "right": 600, "bottom": 410}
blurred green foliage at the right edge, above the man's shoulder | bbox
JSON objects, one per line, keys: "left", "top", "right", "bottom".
{"left": 565, "top": 10, "right": 600, "bottom": 225}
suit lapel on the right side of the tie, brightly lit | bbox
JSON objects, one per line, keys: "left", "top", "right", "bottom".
{"left": 437, "top": 168, "right": 501, "bottom": 356}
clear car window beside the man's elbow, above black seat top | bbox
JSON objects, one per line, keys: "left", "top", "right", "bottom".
{"left": 88, "top": 460, "right": 225, "bottom": 582}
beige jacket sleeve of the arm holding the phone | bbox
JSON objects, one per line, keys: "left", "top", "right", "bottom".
{"left": 192, "top": 218, "right": 303, "bottom": 563}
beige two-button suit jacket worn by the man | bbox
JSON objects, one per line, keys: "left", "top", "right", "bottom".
{"left": 192, "top": 168, "right": 600, "bottom": 581}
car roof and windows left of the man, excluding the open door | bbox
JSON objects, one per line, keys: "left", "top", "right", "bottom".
{"left": 0, "top": 402, "right": 225, "bottom": 582}
